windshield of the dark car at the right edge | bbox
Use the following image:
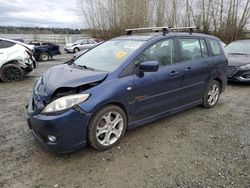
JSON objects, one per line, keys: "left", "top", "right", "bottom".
{"left": 225, "top": 41, "right": 250, "bottom": 54}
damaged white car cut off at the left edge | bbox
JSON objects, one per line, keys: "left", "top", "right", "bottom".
{"left": 0, "top": 38, "right": 36, "bottom": 82}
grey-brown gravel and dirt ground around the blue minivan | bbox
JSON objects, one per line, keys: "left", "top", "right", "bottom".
{"left": 0, "top": 55, "right": 250, "bottom": 188}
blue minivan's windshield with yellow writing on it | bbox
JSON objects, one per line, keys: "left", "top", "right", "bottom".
{"left": 74, "top": 40, "right": 145, "bottom": 72}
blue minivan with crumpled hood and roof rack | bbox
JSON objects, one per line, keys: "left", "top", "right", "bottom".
{"left": 27, "top": 28, "right": 227, "bottom": 153}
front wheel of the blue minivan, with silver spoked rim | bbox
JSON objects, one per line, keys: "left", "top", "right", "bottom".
{"left": 87, "top": 105, "right": 127, "bottom": 151}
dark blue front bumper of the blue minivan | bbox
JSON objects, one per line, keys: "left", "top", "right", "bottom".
{"left": 26, "top": 95, "right": 91, "bottom": 153}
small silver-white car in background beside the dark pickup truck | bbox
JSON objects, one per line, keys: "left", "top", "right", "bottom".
{"left": 64, "top": 38, "right": 98, "bottom": 53}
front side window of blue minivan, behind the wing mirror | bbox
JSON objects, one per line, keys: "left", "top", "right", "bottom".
{"left": 135, "top": 39, "right": 175, "bottom": 67}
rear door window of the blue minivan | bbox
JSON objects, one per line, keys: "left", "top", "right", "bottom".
{"left": 179, "top": 39, "right": 208, "bottom": 61}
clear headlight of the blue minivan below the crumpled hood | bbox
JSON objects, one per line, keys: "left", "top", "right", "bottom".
{"left": 42, "top": 94, "right": 90, "bottom": 114}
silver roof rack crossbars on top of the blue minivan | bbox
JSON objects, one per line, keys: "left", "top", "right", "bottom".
{"left": 125, "top": 26, "right": 199, "bottom": 35}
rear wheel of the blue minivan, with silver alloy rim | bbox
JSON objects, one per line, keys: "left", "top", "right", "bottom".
{"left": 203, "top": 80, "right": 221, "bottom": 108}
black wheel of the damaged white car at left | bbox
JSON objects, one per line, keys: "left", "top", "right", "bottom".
{"left": 0, "top": 64, "right": 24, "bottom": 82}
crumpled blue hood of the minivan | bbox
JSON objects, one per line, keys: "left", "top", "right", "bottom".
{"left": 35, "top": 64, "right": 108, "bottom": 100}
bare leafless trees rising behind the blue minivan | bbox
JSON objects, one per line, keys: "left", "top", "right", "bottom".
{"left": 77, "top": 0, "right": 250, "bottom": 43}
